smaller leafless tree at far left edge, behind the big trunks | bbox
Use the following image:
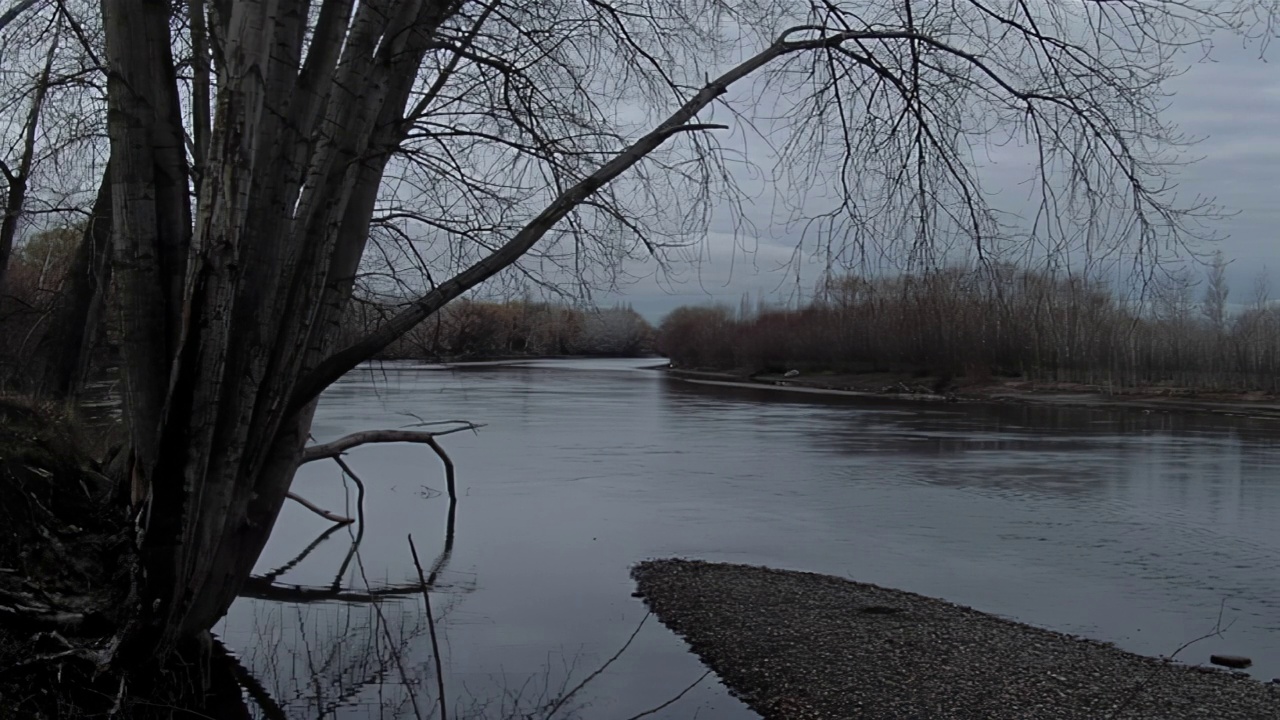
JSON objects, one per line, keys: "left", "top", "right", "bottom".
{"left": 0, "top": 0, "right": 111, "bottom": 397}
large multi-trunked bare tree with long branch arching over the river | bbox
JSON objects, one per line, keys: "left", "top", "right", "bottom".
{"left": 77, "top": 0, "right": 1269, "bottom": 657}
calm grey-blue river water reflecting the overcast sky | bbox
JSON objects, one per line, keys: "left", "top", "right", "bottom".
{"left": 218, "top": 360, "right": 1280, "bottom": 719}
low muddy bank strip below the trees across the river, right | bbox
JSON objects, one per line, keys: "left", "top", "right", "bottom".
{"left": 666, "top": 368, "right": 1280, "bottom": 420}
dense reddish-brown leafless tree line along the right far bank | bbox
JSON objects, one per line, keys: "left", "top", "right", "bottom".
{"left": 655, "top": 254, "right": 1280, "bottom": 392}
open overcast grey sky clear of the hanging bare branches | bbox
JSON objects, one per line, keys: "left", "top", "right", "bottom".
{"left": 599, "top": 31, "right": 1280, "bottom": 320}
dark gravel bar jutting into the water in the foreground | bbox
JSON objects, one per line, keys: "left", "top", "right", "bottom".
{"left": 632, "top": 560, "right": 1280, "bottom": 720}
